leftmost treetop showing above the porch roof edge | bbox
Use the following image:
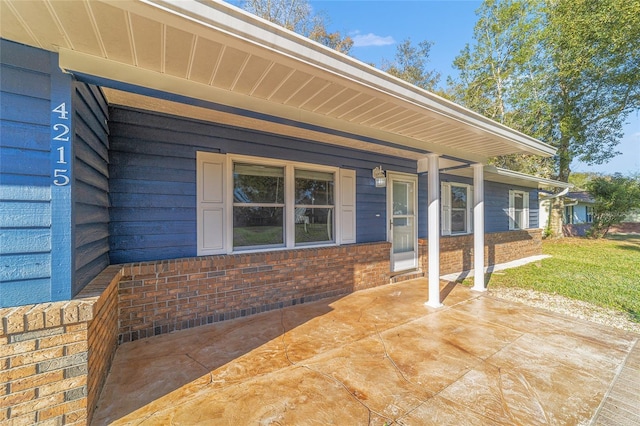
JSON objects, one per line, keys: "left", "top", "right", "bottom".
{"left": 242, "top": 0, "right": 353, "bottom": 54}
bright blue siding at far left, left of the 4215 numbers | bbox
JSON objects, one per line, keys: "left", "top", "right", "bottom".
{"left": 0, "top": 40, "right": 57, "bottom": 307}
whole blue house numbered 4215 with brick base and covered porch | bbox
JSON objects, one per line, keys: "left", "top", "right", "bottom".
{"left": 0, "top": 0, "right": 566, "bottom": 423}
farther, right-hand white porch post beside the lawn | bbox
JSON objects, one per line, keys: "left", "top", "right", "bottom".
{"left": 471, "top": 164, "right": 486, "bottom": 291}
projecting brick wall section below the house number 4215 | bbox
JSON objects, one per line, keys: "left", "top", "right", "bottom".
{"left": 0, "top": 267, "right": 121, "bottom": 425}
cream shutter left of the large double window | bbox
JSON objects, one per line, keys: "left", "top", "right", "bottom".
{"left": 196, "top": 152, "right": 226, "bottom": 256}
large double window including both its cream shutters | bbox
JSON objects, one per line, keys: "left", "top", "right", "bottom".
{"left": 197, "top": 152, "right": 355, "bottom": 255}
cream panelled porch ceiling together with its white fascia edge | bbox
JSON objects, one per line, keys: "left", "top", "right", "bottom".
{"left": 0, "top": 0, "right": 554, "bottom": 166}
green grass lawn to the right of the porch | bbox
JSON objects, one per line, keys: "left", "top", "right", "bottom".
{"left": 480, "top": 234, "right": 640, "bottom": 322}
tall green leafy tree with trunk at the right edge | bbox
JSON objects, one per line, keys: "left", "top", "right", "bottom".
{"left": 544, "top": 0, "right": 640, "bottom": 182}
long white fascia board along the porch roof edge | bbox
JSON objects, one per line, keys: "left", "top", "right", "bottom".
{"left": 108, "top": 0, "right": 556, "bottom": 157}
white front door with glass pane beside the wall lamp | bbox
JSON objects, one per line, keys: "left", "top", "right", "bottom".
{"left": 387, "top": 172, "right": 418, "bottom": 272}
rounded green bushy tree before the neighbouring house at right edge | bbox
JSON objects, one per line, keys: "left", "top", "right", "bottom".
{"left": 587, "top": 174, "right": 640, "bottom": 238}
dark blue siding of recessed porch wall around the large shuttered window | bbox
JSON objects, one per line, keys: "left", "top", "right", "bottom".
{"left": 109, "top": 107, "right": 416, "bottom": 263}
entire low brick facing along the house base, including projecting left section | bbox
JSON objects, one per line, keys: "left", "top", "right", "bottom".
{"left": 0, "top": 230, "right": 542, "bottom": 425}
